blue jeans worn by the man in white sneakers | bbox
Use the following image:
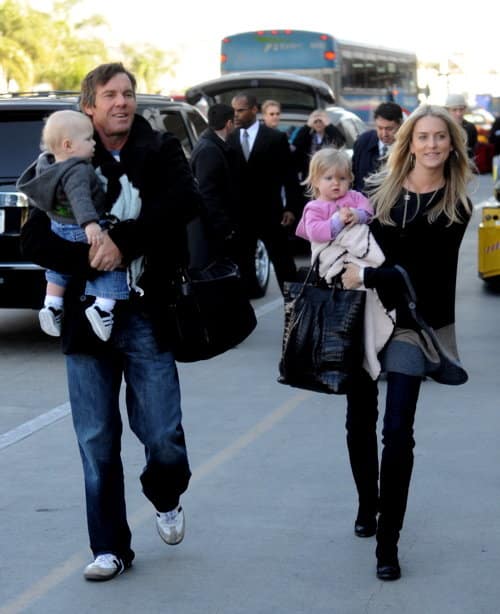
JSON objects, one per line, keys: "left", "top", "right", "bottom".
{"left": 66, "top": 313, "right": 191, "bottom": 563}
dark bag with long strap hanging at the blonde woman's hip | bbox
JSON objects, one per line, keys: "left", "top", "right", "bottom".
{"left": 394, "top": 264, "right": 469, "bottom": 386}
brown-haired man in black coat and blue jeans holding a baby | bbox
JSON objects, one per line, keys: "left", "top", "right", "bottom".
{"left": 22, "top": 63, "right": 201, "bottom": 580}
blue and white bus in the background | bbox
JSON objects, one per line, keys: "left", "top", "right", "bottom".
{"left": 221, "top": 30, "right": 418, "bottom": 122}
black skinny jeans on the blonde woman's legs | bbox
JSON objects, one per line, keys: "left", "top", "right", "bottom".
{"left": 346, "top": 370, "right": 422, "bottom": 543}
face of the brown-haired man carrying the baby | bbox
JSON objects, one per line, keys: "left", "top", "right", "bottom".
{"left": 84, "top": 73, "right": 137, "bottom": 138}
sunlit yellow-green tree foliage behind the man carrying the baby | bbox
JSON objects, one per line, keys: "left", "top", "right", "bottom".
{"left": 0, "top": 0, "right": 178, "bottom": 92}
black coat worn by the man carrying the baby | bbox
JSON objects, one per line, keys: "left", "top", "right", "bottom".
{"left": 21, "top": 116, "right": 201, "bottom": 353}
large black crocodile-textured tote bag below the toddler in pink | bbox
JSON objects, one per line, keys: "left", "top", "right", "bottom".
{"left": 278, "top": 260, "right": 366, "bottom": 394}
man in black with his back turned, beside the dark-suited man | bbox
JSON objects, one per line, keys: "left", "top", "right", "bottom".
{"left": 190, "top": 103, "right": 238, "bottom": 258}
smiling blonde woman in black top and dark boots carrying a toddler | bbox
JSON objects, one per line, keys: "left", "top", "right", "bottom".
{"left": 342, "top": 105, "right": 472, "bottom": 580}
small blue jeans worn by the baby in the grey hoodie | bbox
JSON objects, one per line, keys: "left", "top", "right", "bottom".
{"left": 45, "top": 221, "right": 130, "bottom": 301}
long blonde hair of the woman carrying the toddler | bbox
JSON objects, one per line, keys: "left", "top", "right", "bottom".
{"left": 365, "top": 105, "right": 473, "bottom": 226}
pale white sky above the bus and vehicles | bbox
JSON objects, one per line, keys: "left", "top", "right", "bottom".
{"left": 29, "top": 0, "right": 500, "bottom": 91}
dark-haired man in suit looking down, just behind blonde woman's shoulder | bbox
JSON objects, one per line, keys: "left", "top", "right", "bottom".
{"left": 352, "top": 102, "right": 403, "bottom": 192}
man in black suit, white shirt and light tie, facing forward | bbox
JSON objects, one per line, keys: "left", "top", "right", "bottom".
{"left": 228, "top": 92, "right": 301, "bottom": 290}
